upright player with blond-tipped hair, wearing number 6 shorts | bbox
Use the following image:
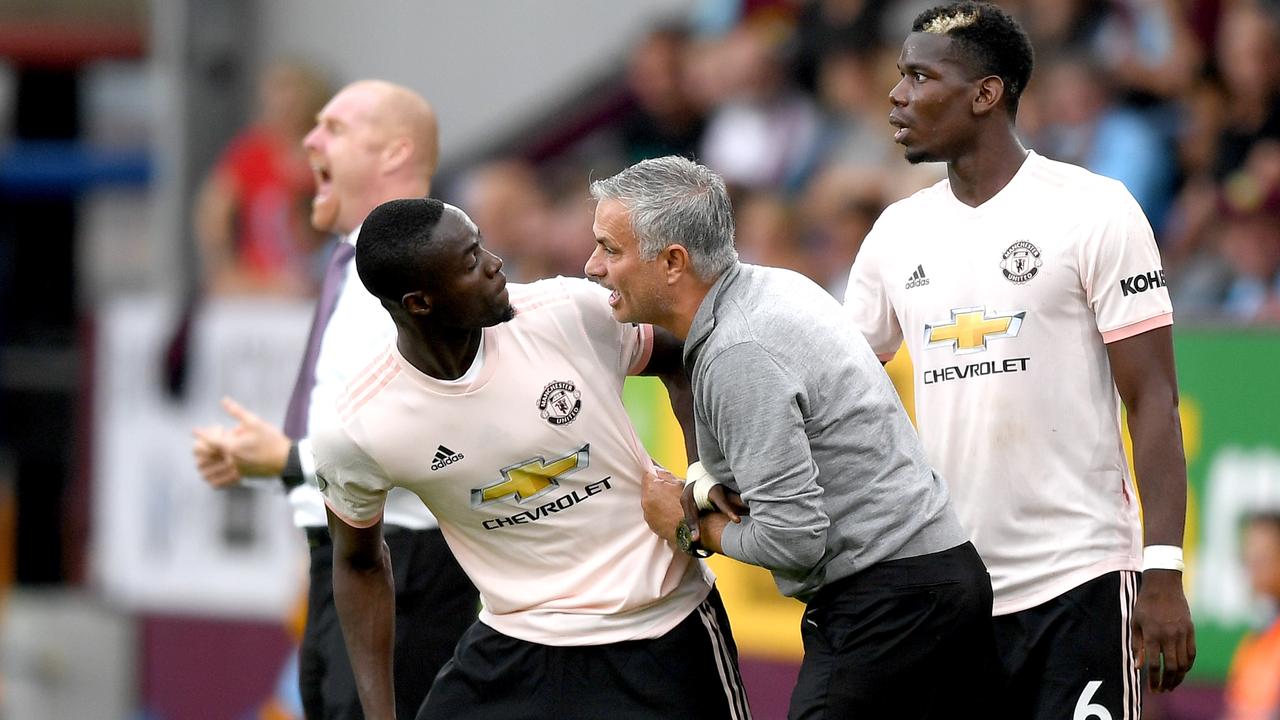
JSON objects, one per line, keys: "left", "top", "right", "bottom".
{"left": 845, "top": 3, "right": 1196, "bottom": 720}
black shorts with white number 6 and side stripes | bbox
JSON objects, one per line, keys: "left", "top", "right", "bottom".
{"left": 995, "top": 570, "right": 1142, "bottom": 720}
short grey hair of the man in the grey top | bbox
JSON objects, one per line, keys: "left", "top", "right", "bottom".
{"left": 591, "top": 155, "right": 737, "bottom": 281}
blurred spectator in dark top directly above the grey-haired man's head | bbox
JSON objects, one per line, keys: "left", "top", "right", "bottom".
{"left": 616, "top": 26, "right": 707, "bottom": 162}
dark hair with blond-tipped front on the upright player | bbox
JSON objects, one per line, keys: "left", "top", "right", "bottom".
{"left": 911, "top": 3, "right": 1036, "bottom": 117}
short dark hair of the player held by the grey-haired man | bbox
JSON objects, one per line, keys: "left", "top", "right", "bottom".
{"left": 356, "top": 197, "right": 444, "bottom": 302}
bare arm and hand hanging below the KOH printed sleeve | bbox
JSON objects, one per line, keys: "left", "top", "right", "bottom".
{"left": 1107, "top": 325, "right": 1196, "bottom": 692}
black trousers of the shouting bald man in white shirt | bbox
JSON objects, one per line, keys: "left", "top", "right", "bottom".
{"left": 298, "top": 527, "right": 480, "bottom": 720}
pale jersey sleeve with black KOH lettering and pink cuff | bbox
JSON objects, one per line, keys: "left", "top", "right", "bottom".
{"left": 1079, "top": 183, "right": 1174, "bottom": 342}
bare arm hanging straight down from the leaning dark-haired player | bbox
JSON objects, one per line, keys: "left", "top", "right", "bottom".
{"left": 328, "top": 510, "right": 396, "bottom": 720}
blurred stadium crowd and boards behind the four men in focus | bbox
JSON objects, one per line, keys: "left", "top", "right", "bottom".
{"left": 0, "top": 0, "right": 1280, "bottom": 720}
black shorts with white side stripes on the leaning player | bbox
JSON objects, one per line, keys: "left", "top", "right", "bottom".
{"left": 417, "top": 588, "right": 751, "bottom": 720}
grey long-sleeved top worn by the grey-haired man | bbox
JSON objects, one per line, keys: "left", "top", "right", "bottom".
{"left": 685, "top": 264, "right": 968, "bottom": 601}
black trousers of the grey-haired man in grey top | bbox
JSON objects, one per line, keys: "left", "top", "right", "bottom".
{"left": 787, "top": 542, "right": 996, "bottom": 720}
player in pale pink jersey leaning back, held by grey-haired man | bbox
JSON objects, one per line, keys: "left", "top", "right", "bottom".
{"left": 315, "top": 199, "right": 750, "bottom": 720}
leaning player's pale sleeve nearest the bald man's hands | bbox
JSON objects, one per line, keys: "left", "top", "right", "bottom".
{"left": 311, "top": 412, "right": 392, "bottom": 528}
